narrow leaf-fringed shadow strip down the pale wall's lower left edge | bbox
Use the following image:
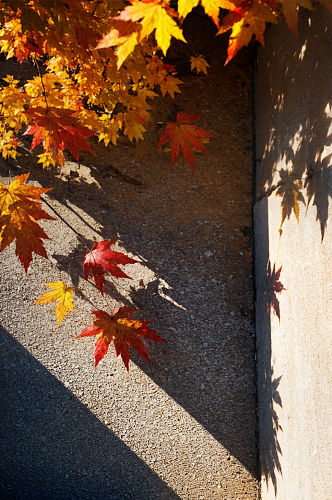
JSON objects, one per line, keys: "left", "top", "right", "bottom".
{"left": 254, "top": 197, "right": 283, "bottom": 495}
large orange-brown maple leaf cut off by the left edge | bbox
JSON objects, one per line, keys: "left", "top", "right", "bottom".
{"left": 0, "top": 174, "right": 55, "bottom": 272}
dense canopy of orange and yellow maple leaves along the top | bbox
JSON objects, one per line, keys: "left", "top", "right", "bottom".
{"left": 0, "top": 0, "right": 332, "bottom": 168}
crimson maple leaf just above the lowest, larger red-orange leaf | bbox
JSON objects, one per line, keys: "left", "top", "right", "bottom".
{"left": 83, "top": 240, "right": 139, "bottom": 293}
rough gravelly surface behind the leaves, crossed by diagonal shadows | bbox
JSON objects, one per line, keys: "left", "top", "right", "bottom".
{"left": 0, "top": 10, "right": 258, "bottom": 500}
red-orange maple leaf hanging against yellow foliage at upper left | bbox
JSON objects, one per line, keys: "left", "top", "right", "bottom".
{"left": 24, "top": 107, "right": 95, "bottom": 164}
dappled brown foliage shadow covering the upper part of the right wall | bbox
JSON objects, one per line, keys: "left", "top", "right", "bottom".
{"left": 257, "top": 9, "right": 332, "bottom": 240}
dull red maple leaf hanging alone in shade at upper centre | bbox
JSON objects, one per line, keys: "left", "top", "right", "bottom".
{"left": 157, "top": 111, "right": 214, "bottom": 172}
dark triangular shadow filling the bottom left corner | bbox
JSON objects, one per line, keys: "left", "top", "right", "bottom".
{"left": 0, "top": 327, "right": 179, "bottom": 500}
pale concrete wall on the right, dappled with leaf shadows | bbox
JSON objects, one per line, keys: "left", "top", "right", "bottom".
{"left": 254, "top": 9, "right": 332, "bottom": 500}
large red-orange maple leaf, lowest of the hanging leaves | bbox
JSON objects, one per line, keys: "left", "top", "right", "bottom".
{"left": 77, "top": 306, "right": 166, "bottom": 371}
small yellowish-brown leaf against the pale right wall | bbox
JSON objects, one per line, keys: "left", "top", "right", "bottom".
{"left": 276, "top": 170, "right": 305, "bottom": 234}
